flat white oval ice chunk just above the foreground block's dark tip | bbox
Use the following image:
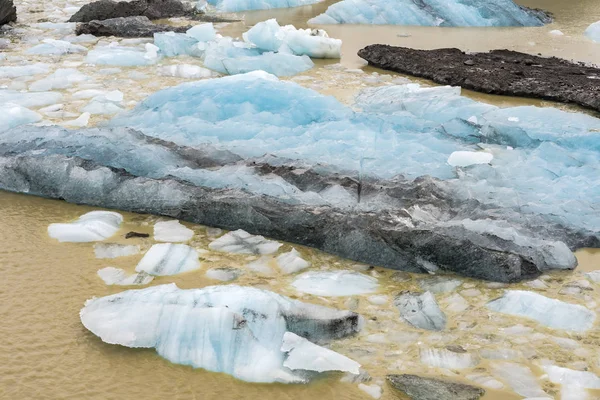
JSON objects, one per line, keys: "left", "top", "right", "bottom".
{"left": 292, "top": 270, "right": 379, "bottom": 297}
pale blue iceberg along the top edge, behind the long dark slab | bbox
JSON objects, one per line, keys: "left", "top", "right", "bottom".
{"left": 308, "top": 0, "right": 550, "bottom": 26}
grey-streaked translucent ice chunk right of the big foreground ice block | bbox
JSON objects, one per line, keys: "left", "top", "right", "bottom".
{"left": 394, "top": 292, "right": 446, "bottom": 331}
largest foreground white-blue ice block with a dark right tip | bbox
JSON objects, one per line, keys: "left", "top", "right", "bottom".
{"left": 80, "top": 284, "right": 360, "bottom": 382}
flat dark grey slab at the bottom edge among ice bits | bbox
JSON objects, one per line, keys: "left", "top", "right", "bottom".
{"left": 387, "top": 374, "right": 485, "bottom": 400}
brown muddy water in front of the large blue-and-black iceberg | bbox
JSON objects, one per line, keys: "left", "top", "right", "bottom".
{"left": 0, "top": 192, "right": 600, "bottom": 400}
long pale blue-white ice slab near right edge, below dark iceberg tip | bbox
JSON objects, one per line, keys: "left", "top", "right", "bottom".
{"left": 487, "top": 290, "right": 596, "bottom": 332}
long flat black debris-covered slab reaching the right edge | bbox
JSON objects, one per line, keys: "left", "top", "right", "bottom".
{"left": 358, "top": 44, "right": 600, "bottom": 111}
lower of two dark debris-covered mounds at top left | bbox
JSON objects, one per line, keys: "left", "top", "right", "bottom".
{"left": 75, "top": 17, "right": 190, "bottom": 38}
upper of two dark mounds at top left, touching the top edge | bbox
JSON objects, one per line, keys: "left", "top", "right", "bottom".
{"left": 69, "top": 0, "right": 194, "bottom": 22}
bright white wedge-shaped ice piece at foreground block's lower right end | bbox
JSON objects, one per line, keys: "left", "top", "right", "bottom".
{"left": 281, "top": 332, "right": 360, "bottom": 375}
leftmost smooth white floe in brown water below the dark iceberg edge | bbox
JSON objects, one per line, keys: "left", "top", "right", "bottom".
{"left": 48, "top": 211, "right": 123, "bottom": 242}
